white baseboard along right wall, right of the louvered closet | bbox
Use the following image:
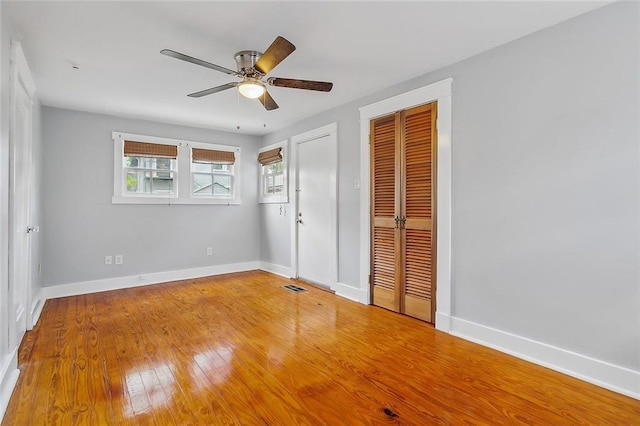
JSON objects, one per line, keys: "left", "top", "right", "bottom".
{"left": 448, "top": 317, "right": 640, "bottom": 399}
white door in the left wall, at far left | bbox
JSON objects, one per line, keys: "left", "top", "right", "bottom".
{"left": 9, "top": 46, "right": 33, "bottom": 346}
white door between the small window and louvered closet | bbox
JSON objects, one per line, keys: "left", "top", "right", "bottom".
{"left": 296, "top": 130, "right": 337, "bottom": 288}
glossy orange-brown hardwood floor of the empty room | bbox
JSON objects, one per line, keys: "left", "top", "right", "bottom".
{"left": 2, "top": 271, "right": 640, "bottom": 425}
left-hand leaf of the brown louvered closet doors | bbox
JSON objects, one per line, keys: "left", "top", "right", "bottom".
{"left": 370, "top": 114, "right": 401, "bottom": 312}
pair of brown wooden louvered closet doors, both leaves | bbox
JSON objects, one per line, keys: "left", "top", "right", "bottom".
{"left": 370, "top": 103, "right": 437, "bottom": 322}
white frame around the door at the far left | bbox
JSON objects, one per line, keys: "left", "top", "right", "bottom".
{"left": 8, "top": 40, "right": 36, "bottom": 347}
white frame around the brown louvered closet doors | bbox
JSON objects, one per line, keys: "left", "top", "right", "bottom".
{"left": 359, "top": 78, "right": 453, "bottom": 331}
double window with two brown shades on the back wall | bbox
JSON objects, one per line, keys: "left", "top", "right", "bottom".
{"left": 113, "top": 132, "right": 240, "bottom": 204}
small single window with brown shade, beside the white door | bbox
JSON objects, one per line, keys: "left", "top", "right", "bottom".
{"left": 258, "top": 141, "right": 289, "bottom": 203}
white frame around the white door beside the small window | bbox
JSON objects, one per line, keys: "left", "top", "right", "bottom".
{"left": 289, "top": 122, "right": 338, "bottom": 290}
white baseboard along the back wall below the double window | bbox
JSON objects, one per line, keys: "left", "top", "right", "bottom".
{"left": 42, "top": 261, "right": 260, "bottom": 300}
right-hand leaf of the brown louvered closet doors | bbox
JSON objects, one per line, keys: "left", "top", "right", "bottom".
{"left": 401, "top": 104, "right": 436, "bottom": 322}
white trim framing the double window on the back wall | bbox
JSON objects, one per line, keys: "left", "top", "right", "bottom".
{"left": 111, "top": 132, "right": 242, "bottom": 205}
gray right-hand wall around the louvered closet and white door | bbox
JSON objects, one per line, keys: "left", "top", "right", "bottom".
{"left": 261, "top": 2, "right": 640, "bottom": 370}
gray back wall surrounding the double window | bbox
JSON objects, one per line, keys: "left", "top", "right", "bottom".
{"left": 42, "top": 107, "right": 260, "bottom": 286}
